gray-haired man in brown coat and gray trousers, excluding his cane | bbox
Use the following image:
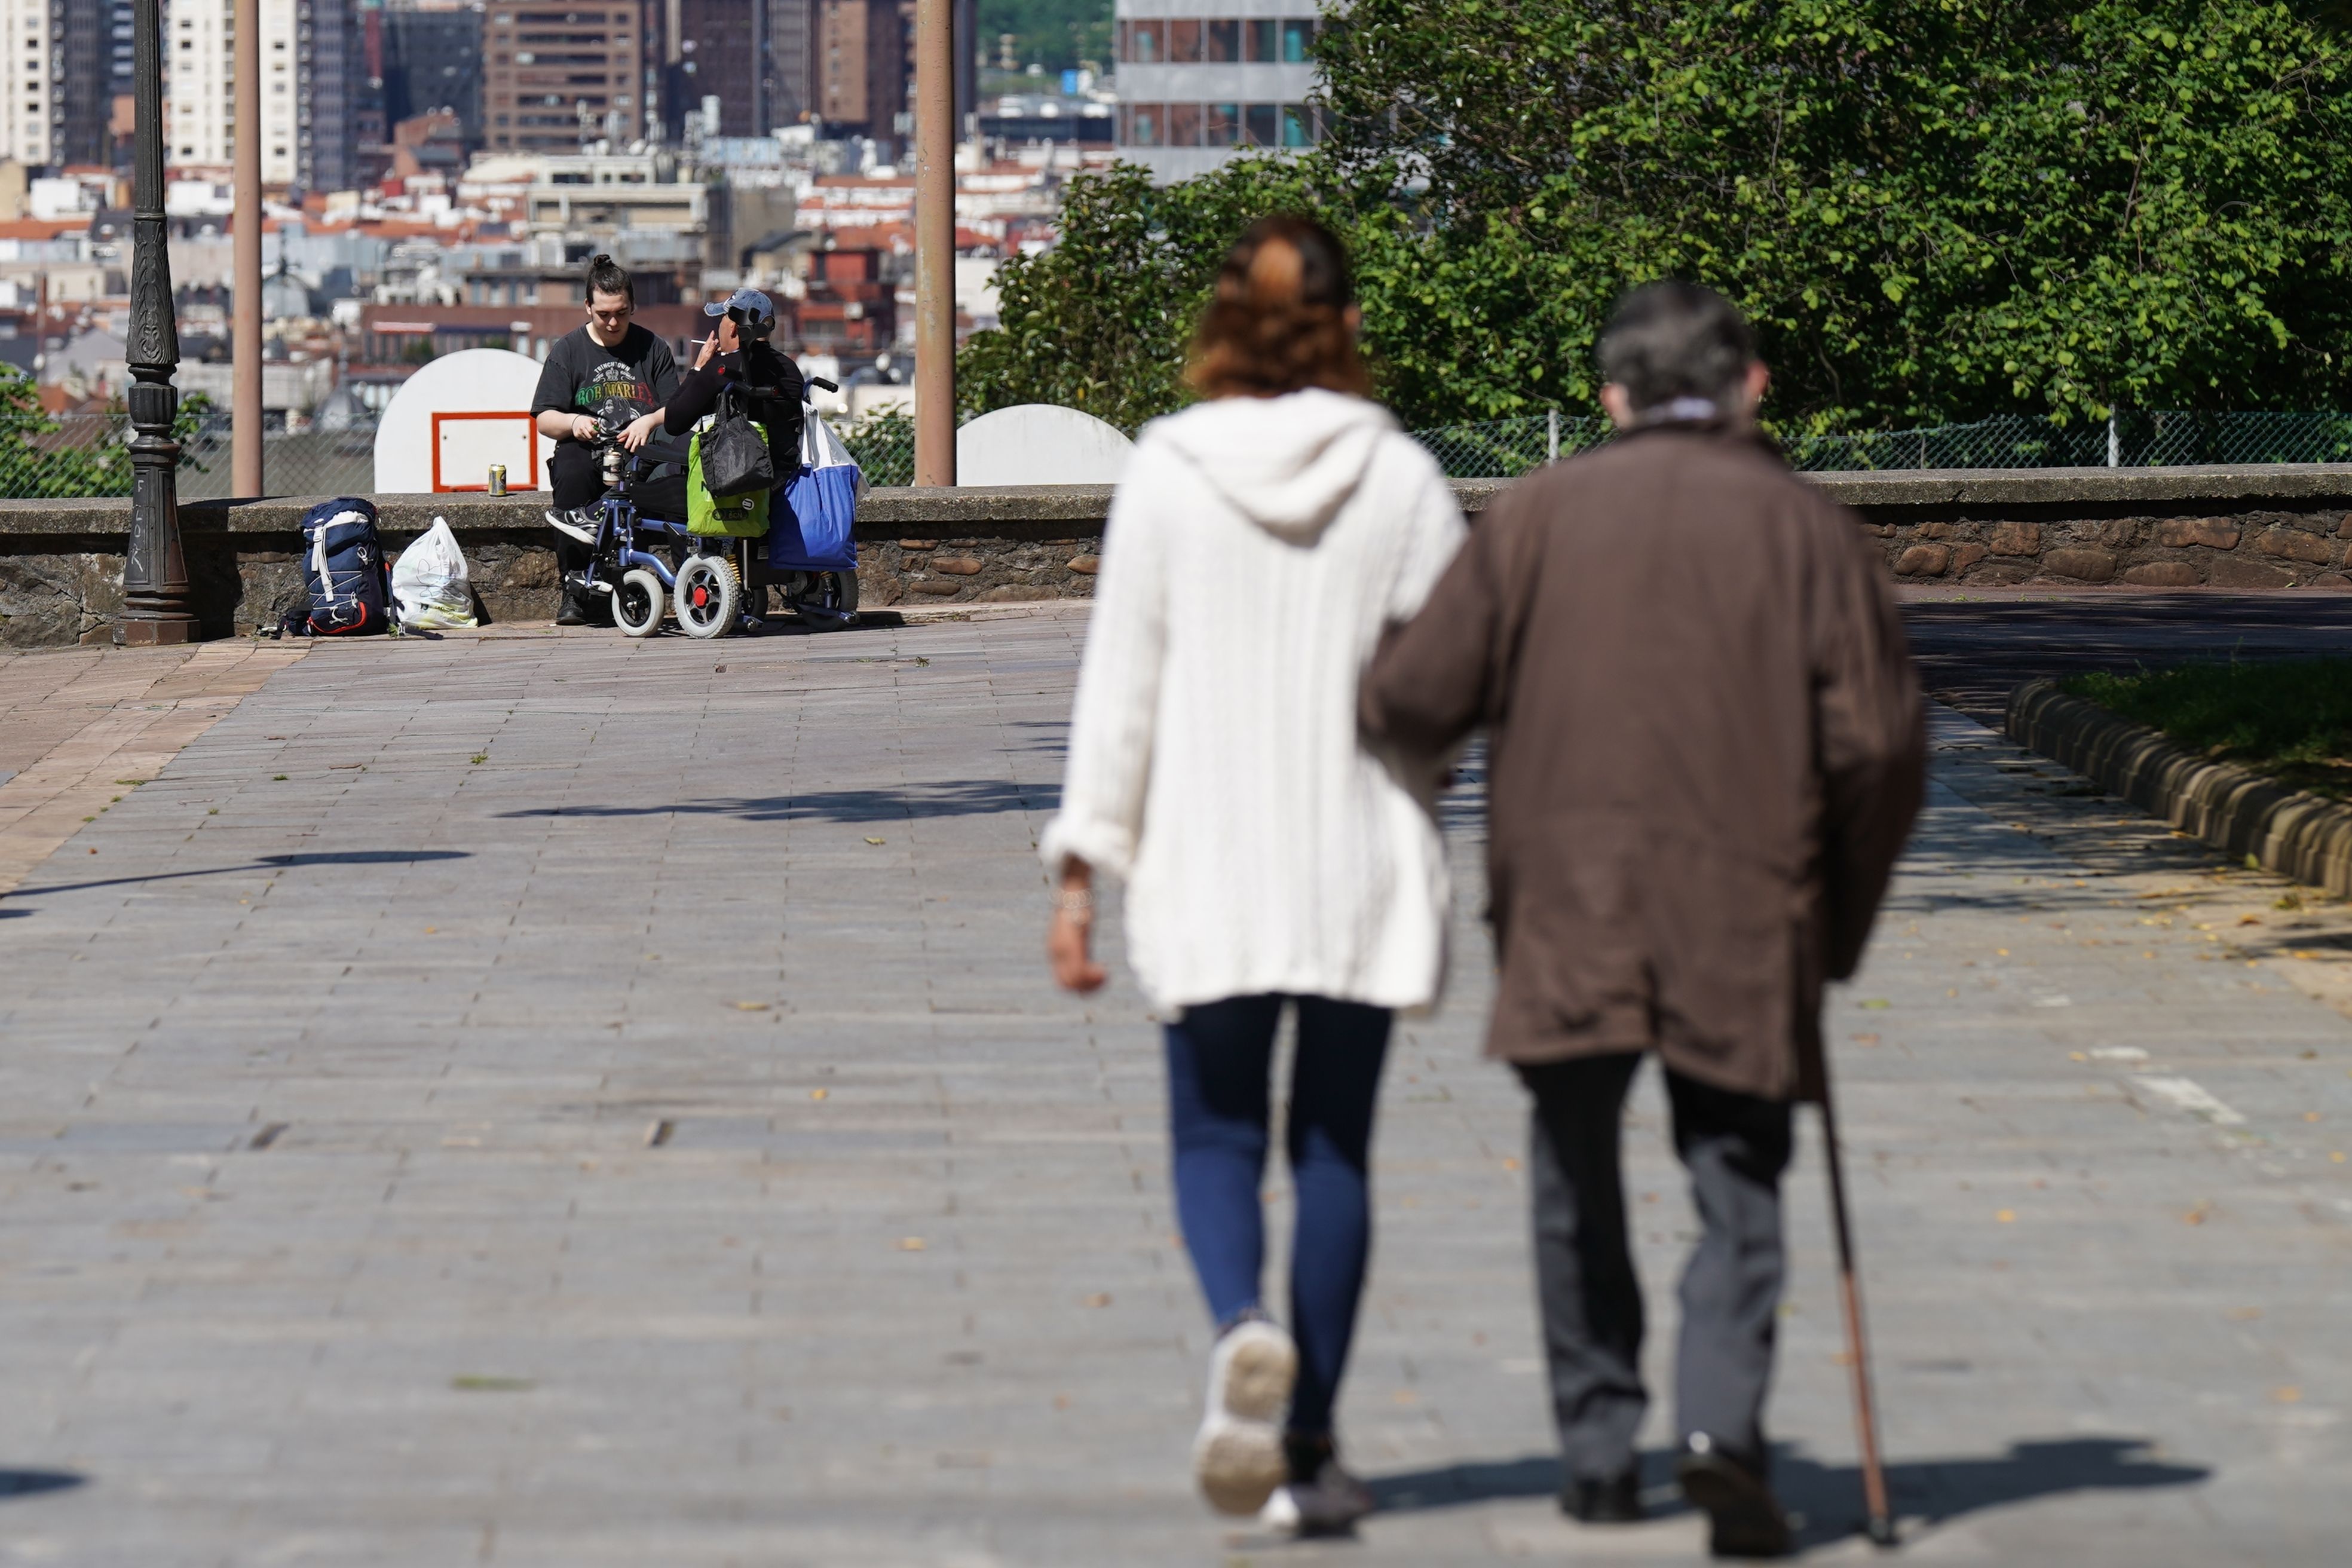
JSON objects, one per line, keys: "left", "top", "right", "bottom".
{"left": 1362, "top": 282, "right": 1924, "bottom": 1556}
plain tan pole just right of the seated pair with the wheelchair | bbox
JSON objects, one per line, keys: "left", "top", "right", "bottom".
{"left": 915, "top": 0, "right": 955, "bottom": 484}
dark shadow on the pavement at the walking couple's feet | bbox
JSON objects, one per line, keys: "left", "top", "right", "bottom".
{"left": 1367, "top": 1437, "right": 2213, "bottom": 1547}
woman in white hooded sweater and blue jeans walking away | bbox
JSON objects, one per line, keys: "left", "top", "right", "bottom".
{"left": 1042, "top": 219, "right": 1463, "bottom": 1530}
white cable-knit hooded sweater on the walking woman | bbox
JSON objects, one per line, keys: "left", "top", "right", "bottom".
{"left": 1040, "top": 390, "right": 1463, "bottom": 1009}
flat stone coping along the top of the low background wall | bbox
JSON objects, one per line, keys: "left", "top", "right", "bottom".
{"left": 14, "top": 463, "right": 2352, "bottom": 538}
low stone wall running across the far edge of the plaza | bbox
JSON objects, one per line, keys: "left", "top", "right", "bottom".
{"left": 14, "top": 466, "right": 2352, "bottom": 647}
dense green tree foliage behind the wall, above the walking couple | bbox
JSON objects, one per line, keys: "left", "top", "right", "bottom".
{"left": 976, "top": 0, "right": 2352, "bottom": 430}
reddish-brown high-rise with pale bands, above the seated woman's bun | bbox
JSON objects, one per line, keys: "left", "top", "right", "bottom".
{"left": 482, "top": 0, "right": 647, "bottom": 153}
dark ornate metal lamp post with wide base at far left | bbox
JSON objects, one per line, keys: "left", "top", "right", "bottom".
{"left": 115, "top": 0, "right": 195, "bottom": 644}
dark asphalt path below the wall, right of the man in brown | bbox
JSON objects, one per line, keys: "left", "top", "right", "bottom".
{"left": 1903, "top": 590, "right": 2352, "bottom": 724}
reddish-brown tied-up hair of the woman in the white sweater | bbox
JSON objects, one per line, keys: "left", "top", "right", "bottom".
{"left": 1186, "top": 216, "right": 1371, "bottom": 397}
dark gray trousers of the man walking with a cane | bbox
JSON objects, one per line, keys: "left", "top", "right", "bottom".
{"left": 1520, "top": 1053, "right": 1790, "bottom": 1481}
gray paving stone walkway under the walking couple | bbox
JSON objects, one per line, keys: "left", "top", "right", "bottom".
{"left": 0, "top": 614, "right": 2352, "bottom": 1568}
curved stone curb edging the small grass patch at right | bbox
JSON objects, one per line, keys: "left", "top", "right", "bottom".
{"left": 2004, "top": 679, "right": 2352, "bottom": 898}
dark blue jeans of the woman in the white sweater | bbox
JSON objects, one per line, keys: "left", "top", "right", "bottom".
{"left": 1166, "top": 997, "right": 1390, "bottom": 1437}
